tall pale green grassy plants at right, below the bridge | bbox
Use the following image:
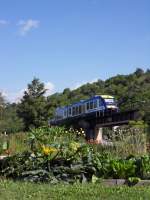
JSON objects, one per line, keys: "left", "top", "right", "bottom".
{"left": 107, "top": 126, "right": 147, "bottom": 157}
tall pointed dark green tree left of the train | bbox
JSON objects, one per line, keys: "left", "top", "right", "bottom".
{"left": 18, "top": 78, "right": 48, "bottom": 130}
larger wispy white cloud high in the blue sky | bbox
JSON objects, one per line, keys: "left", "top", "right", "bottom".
{"left": 17, "top": 19, "right": 40, "bottom": 36}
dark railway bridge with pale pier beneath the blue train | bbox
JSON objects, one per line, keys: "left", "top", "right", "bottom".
{"left": 50, "top": 109, "right": 140, "bottom": 143}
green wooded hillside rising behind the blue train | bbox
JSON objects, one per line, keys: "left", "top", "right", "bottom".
{"left": 48, "top": 68, "right": 150, "bottom": 121}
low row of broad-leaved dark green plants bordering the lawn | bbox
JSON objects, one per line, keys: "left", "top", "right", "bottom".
{"left": 0, "top": 146, "right": 150, "bottom": 183}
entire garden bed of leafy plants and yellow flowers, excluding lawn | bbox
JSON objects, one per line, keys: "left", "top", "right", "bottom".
{"left": 0, "top": 127, "right": 150, "bottom": 184}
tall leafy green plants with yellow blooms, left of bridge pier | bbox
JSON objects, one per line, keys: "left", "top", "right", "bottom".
{"left": 28, "top": 127, "right": 87, "bottom": 160}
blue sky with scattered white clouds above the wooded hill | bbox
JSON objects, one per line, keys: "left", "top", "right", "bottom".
{"left": 0, "top": 0, "right": 150, "bottom": 102}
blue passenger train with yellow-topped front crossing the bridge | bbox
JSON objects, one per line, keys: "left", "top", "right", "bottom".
{"left": 55, "top": 95, "right": 119, "bottom": 120}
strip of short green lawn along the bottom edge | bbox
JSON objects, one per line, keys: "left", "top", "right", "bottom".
{"left": 0, "top": 180, "right": 150, "bottom": 200}
